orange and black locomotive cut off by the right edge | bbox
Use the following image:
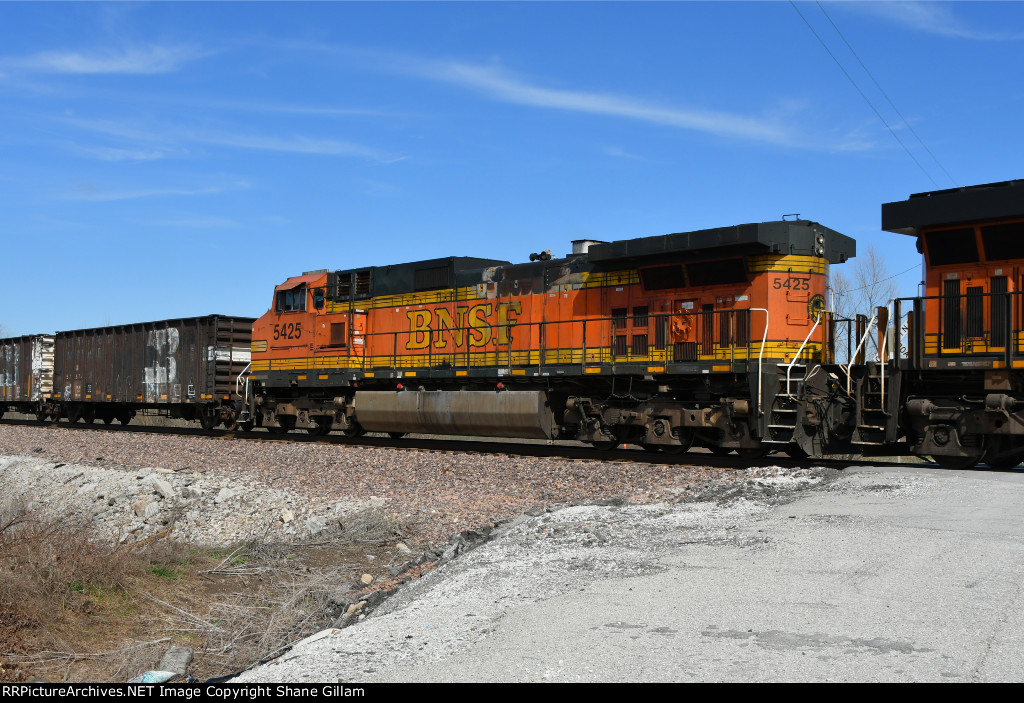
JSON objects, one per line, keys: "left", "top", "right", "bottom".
{"left": 876, "top": 180, "right": 1024, "bottom": 468}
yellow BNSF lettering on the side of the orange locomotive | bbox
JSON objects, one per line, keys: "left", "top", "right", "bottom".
{"left": 406, "top": 302, "right": 522, "bottom": 349}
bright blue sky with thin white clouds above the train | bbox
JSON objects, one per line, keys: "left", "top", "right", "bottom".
{"left": 0, "top": 2, "right": 1024, "bottom": 335}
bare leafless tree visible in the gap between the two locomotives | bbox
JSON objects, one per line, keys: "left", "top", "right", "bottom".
{"left": 829, "top": 247, "right": 898, "bottom": 362}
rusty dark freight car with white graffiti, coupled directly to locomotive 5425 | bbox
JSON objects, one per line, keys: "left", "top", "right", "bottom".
{"left": 53, "top": 315, "right": 253, "bottom": 429}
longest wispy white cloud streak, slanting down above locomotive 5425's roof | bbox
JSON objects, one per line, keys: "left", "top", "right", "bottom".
{"left": 400, "top": 61, "right": 795, "bottom": 144}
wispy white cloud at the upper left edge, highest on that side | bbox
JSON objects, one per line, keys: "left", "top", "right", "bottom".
{"left": 0, "top": 45, "right": 209, "bottom": 74}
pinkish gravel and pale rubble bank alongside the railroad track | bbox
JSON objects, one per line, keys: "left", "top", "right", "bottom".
{"left": 0, "top": 426, "right": 827, "bottom": 547}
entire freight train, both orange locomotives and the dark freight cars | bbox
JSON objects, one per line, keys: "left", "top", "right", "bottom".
{"left": 6, "top": 181, "right": 1024, "bottom": 468}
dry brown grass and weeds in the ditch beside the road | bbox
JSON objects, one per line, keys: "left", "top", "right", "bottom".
{"left": 0, "top": 506, "right": 408, "bottom": 682}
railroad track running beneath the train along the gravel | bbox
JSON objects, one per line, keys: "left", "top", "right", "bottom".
{"left": 0, "top": 419, "right": 913, "bottom": 471}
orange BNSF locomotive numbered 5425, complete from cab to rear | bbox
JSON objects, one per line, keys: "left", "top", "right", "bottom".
{"left": 242, "top": 220, "right": 855, "bottom": 454}
